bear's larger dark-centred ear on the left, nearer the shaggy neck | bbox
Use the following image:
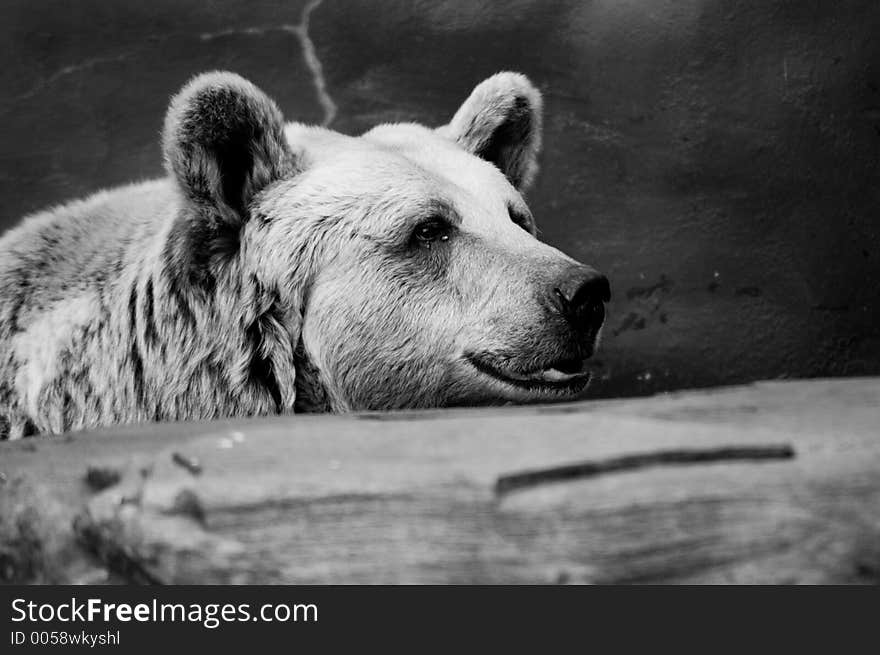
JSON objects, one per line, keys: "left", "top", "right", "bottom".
{"left": 163, "top": 72, "right": 294, "bottom": 227}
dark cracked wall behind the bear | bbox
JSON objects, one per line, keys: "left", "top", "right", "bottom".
{"left": 0, "top": 0, "right": 880, "bottom": 395}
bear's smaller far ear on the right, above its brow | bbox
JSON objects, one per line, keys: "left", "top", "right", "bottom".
{"left": 437, "top": 73, "right": 543, "bottom": 190}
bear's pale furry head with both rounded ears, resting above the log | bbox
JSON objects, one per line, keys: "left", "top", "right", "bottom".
{"left": 164, "top": 73, "right": 610, "bottom": 411}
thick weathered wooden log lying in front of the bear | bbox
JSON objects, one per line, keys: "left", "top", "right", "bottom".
{"left": 0, "top": 379, "right": 880, "bottom": 583}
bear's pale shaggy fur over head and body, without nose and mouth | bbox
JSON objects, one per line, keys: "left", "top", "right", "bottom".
{"left": 0, "top": 73, "right": 598, "bottom": 438}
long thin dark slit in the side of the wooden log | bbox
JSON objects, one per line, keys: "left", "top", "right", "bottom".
{"left": 495, "top": 444, "right": 795, "bottom": 495}
